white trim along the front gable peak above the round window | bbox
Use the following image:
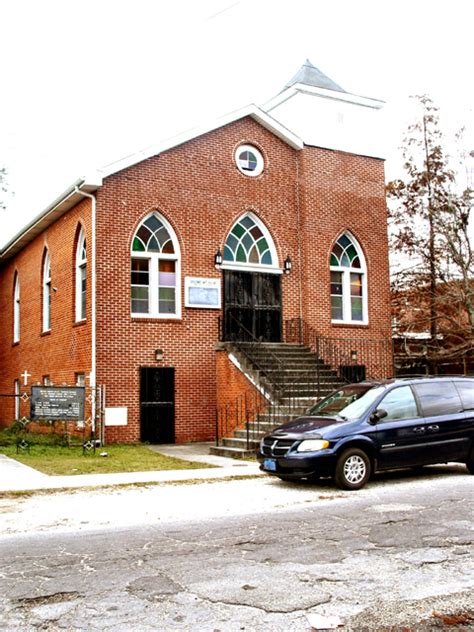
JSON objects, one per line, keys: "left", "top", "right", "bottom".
{"left": 99, "top": 104, "right": 303, "bottom": 178}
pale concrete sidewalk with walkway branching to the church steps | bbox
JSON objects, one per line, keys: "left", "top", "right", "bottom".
{"left": 0, "top": 443, "right": 263, "bottom": 493}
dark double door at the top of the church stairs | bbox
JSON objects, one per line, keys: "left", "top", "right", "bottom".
{"left": 223, "top": 270, "right": 282, "bottom": 342}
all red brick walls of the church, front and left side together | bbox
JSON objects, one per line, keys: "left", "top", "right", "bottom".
{"left": 0, "top": 118, "right": 390, "bottom": 442}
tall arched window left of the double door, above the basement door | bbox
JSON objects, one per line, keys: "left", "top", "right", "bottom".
{"left": 131, "top": 212, "right": 181, "bottom": 318}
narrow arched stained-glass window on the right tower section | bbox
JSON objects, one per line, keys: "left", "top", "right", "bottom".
{"left": 330, "top": 233, "right": 367, "bottom": 323}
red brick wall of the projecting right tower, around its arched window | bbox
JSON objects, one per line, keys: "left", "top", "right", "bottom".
{"left": 299, "top": 147, "right": 392, "bottom": 376}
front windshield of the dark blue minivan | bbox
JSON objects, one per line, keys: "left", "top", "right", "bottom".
{"left": 309, "top": 384, "right": 385, "bottom": 420}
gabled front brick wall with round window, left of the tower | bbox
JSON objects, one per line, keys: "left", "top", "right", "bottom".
{"left": 97, "top": 119, "right": 298, "bottom": 442}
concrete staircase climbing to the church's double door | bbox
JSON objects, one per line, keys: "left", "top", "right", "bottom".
{"left": 211, "top": 342, "right": 343, "bottom": 459}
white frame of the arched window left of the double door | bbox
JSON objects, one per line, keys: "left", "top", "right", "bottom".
{"left": 129, "top": 211, "right": 181, "bottom": 320}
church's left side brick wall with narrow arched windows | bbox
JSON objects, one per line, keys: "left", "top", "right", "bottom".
{"left": 0, "top": 201, "right": 91, "bottom": 426}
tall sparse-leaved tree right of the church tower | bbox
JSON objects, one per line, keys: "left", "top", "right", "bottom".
{"left": 388, "top": 96, "right": 474, "bottom": 372}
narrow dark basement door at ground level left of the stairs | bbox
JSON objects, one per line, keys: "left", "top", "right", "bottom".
{"left": 140, "top": 367, "right": 175, "bottom": 443}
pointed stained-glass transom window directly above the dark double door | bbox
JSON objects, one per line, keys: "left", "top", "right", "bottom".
{"left": 224, "top": 214, "right": 274, "bottom": 266}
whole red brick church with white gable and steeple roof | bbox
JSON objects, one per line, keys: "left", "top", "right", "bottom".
{"left": 0, "top": 61, "right": 392, "bottom": 443}
